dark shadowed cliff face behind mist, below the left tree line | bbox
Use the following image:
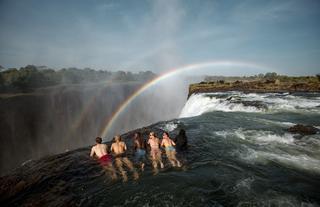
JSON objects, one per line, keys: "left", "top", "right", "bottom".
{"left": 0, "top": 82, "right": 143, "bottom": 174}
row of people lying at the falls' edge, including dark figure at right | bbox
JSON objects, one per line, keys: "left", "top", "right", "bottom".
{"left": 90, "top": 129, "right": 187, "bottom": 181}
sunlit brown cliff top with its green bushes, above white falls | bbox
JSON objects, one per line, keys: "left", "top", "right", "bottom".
{"left": 188, "top": 74, "right": 320, "bottom": 97}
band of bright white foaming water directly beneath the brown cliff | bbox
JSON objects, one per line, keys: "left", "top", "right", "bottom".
{"left": 180, "top": 92, "right": 320, "bottom": 118}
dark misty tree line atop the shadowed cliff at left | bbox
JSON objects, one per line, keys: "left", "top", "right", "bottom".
{"left": 0, "top": 65, "right": 156, "bottom": 93}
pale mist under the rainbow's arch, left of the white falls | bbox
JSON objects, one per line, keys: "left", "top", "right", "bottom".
{"left": 102, "top": 75, "right": 203, "bottom": 137}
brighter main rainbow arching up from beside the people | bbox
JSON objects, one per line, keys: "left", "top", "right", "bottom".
{"left": 100, "top": 61, "right": 274, "bottom": 137}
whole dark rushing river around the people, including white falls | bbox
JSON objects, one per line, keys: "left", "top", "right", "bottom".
{"left": 0, "top": 92, "right": 320, "bottom": 206}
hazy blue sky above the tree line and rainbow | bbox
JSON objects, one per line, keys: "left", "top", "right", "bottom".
{"left": 0, "top": 0, "right": 320, "bottom": 75}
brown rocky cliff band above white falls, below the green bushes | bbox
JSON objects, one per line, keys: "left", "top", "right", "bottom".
{"left": 188, "top": 77, "right": 320, "bottom": 97}
